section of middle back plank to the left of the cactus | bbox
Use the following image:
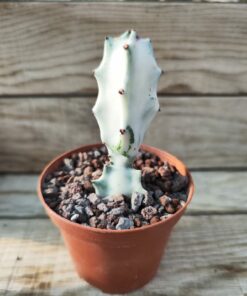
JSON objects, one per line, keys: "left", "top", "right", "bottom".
{"left": 0, "top": 98, "right": 99, "bottom": 172}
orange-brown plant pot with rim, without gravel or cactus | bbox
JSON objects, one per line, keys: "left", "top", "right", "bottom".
{"left": 38, "top": 144, "right": 194, "bottom": 293}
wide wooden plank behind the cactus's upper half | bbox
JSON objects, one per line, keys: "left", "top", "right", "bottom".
{"left": 0, "top": 2, "right": 247, "bottom": 94}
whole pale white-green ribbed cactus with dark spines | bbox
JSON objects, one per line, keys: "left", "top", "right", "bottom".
{"left": 93, "top": 30, "right": 162, "bottom": 196}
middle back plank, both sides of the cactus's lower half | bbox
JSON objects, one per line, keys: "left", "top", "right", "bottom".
{"left": 0, "top": 96, "right": 247, "bottom": 172}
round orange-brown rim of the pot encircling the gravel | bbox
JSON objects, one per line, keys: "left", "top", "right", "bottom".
{"left": 37, "top": 143, "right": 195, "bottom": 234}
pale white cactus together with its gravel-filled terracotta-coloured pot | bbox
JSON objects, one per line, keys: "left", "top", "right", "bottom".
{"left": 38, "top": 30, "right": 194, "bottom": 293}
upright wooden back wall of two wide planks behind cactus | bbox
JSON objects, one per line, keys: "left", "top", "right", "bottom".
{"left": 0, "top": 2, "right": 247, "bottom": 173}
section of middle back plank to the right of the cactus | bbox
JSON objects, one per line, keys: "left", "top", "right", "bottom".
{"left": 145, "top": 96, "right": 247, "bottom": 168}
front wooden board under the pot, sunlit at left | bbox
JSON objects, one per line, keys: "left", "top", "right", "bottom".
{"left": 0, "top": 215, "right": 247, "bottom": 296}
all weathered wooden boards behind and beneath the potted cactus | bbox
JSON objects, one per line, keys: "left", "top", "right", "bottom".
{"left": 0, "top": 0, "right": 247, "bottom": 296}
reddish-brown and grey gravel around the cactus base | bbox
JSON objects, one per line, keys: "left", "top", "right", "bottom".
{"left": 42, "top": 146, "right": 188, "bottom": 230}
